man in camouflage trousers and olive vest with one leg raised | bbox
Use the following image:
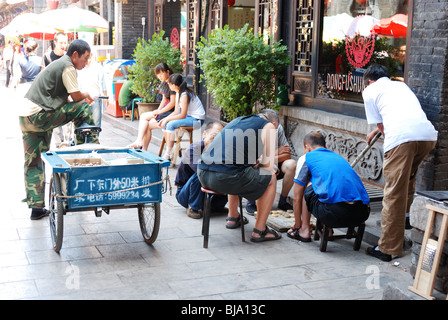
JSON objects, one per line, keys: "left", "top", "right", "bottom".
{"left": 19, "top": 40, "right": 98, "bottom": 220}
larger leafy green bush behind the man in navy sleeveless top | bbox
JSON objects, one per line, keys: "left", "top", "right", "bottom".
{"left": 196, "top": 24, "right": 291, "bottom": 121}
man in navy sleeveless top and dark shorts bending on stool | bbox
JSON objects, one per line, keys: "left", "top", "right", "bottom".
{"left": 198, "top": 110, "right": 281, "bottom": 242}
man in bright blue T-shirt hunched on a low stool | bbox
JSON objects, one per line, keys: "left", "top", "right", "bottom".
{"left": 287, "top": 132, "right": 370, "bottom": 242}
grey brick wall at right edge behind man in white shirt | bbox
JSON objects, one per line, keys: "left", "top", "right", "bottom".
{"left": 408, "top": 0, "right": 448, "bottom": 190}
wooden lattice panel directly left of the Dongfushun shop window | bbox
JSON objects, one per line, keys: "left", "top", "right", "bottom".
{"left": 294, "top": 0, "right": 314, "bottom": 72}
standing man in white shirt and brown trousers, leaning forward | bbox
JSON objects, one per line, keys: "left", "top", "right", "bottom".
{"left": 362, "top": 65, "right": 437, "bottom": 261}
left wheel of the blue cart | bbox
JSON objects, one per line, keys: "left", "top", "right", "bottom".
{"left": 49, "top": 173, "right": 64, "bottom": 252}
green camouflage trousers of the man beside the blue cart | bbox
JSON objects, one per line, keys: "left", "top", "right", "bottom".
{"left": 19, "top": 101, "right": 98, "bottom": 208}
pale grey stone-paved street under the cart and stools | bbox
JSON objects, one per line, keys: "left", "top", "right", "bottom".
{"left": 0, "top": 74, "right": 424, "bottom": 301}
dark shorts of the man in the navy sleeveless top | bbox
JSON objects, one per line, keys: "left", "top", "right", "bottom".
{"left": 198, "top": 167, "right": 272, "bottom": 202}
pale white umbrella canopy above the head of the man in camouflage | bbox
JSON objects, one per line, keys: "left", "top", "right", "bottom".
{"left": 38, "top": 7, "right": 109, "bottom": 33}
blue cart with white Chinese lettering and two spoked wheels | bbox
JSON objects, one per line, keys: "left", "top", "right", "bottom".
{"left": 42, "top": 149, "right": 170, "bottom": 252}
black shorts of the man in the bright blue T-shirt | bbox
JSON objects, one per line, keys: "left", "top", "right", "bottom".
{"left": 304, "top": 185, "right": 370, "bottom": 228}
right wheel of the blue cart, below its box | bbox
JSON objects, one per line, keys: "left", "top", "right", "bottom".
{"left": 138, "top": 202, "right": 160, "bottom": 244}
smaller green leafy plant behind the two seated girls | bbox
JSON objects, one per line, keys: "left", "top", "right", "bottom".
{"left": 130, "top": 30, "right": 182, "bottom": 102}
